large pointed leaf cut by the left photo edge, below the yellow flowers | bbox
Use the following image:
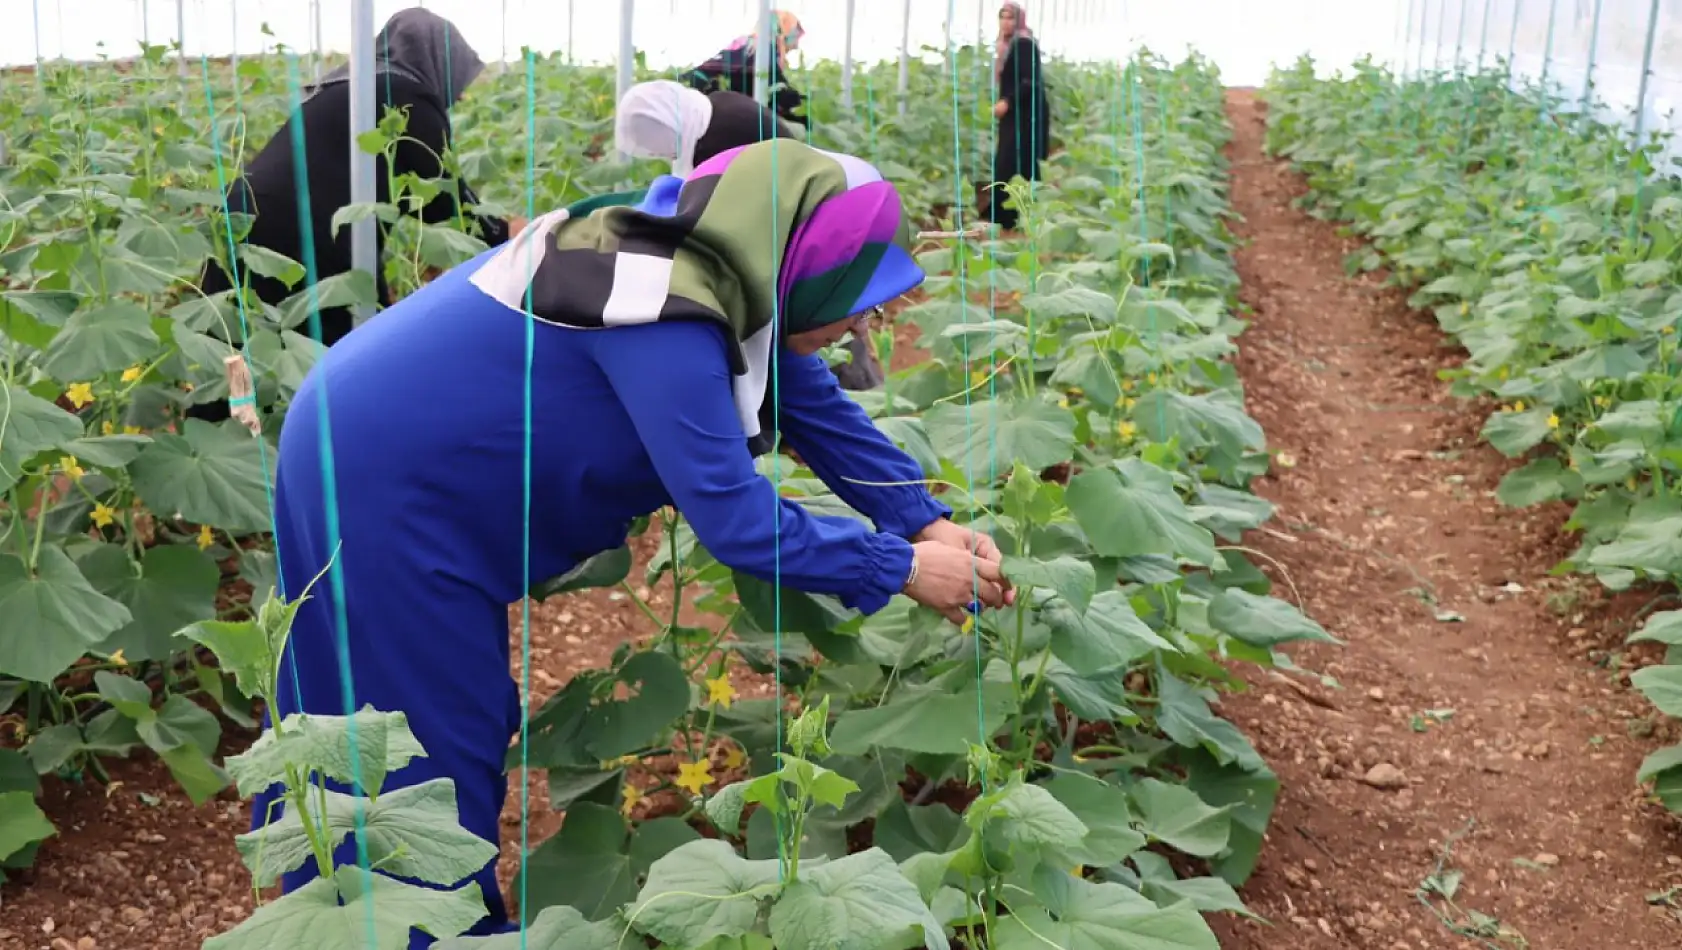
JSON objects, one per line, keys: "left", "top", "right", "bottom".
{"left": 0, "top": 546, "right": 133, "bottom": 683}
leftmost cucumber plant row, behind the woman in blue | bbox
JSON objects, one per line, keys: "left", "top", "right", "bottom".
{"left": 0, "top": 40, "right": 995, "bottom": 876}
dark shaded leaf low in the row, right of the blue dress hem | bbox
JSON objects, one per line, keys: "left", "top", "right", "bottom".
{"left": 521, "top": 802, "right": 701, "bottom": 920}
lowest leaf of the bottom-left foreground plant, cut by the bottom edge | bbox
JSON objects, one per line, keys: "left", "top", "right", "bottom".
{"left": 204, "top": 868, "right": 486, "bottom": 950}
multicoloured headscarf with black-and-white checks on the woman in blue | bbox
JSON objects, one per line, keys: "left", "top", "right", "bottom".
{"left": 471, "top": 140, "right": 923, "bottom": 452}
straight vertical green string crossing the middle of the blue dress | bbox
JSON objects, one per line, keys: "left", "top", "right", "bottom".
{"left": 520, "top": 47, "right": 537, "bottom": 950}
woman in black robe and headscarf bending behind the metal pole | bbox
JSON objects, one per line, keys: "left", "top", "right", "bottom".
{"left": 187, "top": 7, "right": 510, "bottom": 422}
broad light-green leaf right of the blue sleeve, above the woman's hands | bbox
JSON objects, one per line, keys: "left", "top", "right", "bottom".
{"left": 923, "top": 398, "right": 1075, "bottom": 479}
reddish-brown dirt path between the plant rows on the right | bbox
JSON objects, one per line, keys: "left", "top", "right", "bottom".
{"left": 1219, "top": 91, "right": 1682, "bottom": 950}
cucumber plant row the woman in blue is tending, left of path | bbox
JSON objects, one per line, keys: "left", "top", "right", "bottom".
{"left": 185, "top": 55, "right": 1330, "bottom": 950}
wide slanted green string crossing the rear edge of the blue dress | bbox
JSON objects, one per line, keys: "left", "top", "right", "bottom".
{"left": 286, "top": 54, "right": 378, "bottom": 947}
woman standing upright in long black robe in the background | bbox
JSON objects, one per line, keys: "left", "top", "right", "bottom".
{"left": 981, "top": 3, "right": 1051, "bottom": 230}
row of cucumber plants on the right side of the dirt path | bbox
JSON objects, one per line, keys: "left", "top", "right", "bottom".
{"left": 1265, "top": 61, "right": 1682, "bottom": 812}
